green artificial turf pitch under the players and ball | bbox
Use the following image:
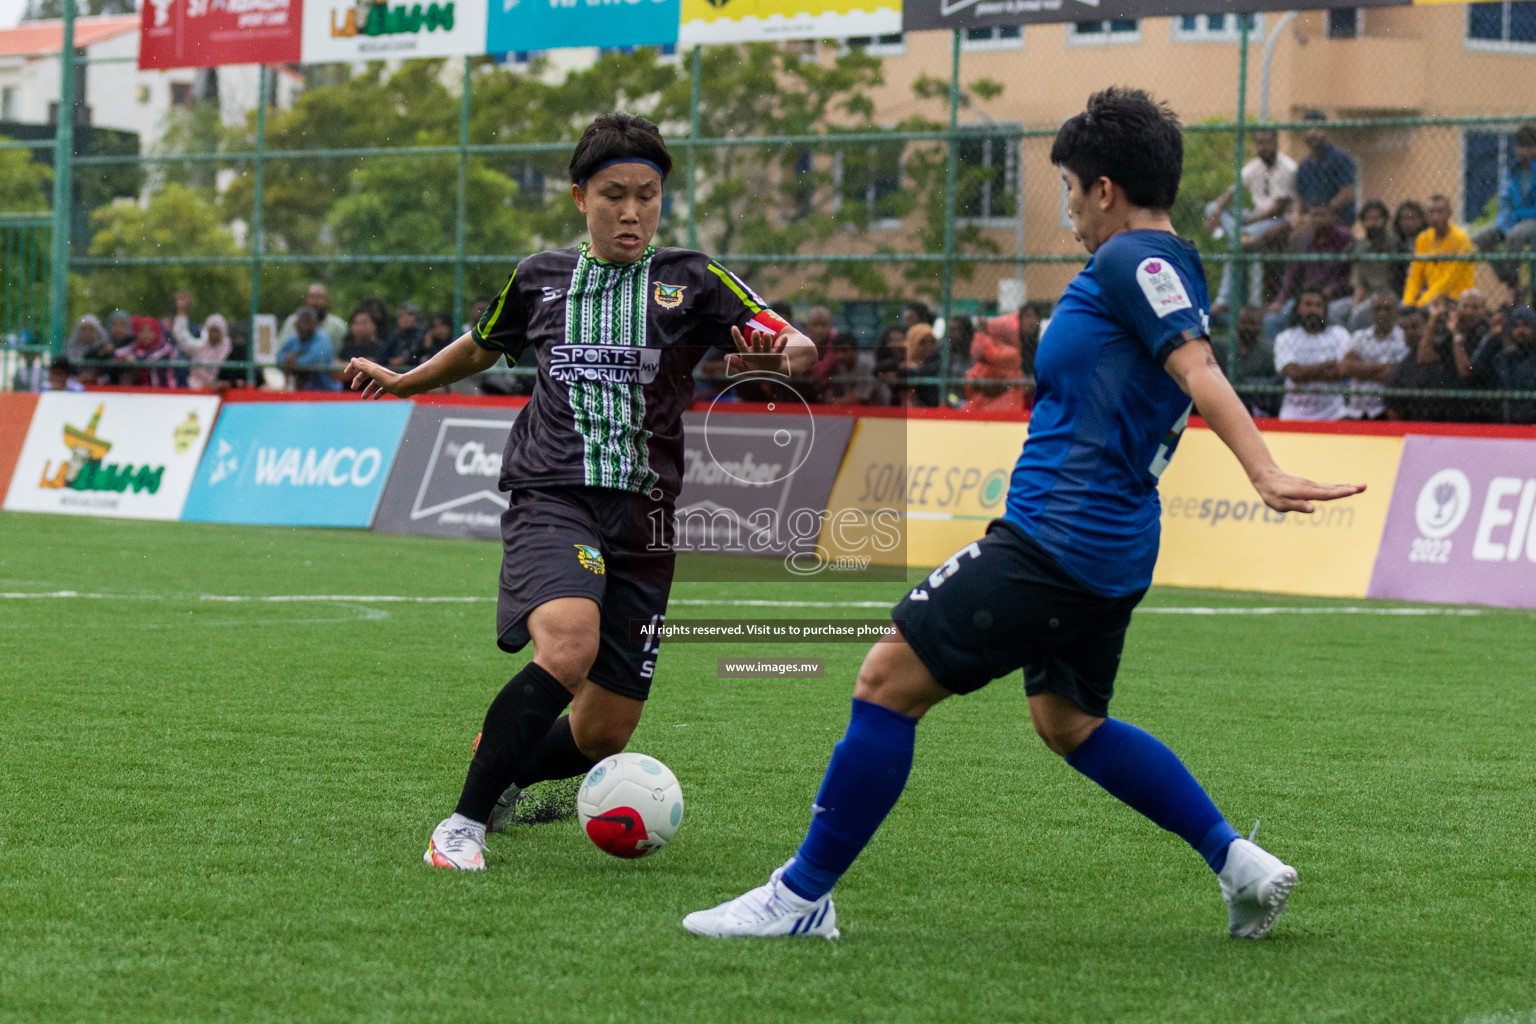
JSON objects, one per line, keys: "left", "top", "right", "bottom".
{"left": 0, "top": 514, "right": 1536, "bottom": 1024}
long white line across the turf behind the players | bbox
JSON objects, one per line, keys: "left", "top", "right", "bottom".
{"left": 0, "top": 590, "right": 1488, "bottom": 616}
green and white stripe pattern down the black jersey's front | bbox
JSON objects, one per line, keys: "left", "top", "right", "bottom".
{"left": 565, "top": 244, "right": 659, "bottom": 493}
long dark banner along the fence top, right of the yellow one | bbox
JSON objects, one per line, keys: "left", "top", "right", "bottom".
{"left": 903, "top": 0, "right": 1406, "bottom": 33}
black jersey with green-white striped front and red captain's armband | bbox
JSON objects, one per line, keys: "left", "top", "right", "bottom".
{"left": 472, "top": 244, "right": 785, "bottom": 500}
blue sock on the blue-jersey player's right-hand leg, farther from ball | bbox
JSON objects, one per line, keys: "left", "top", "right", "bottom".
{"left": 1066, "top": 718, "right": 1240, "bottom": 870}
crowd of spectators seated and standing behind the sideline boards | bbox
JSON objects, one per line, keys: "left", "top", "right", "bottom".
{"left": 17, "top": 121, "right": 1536, "bottom": 422}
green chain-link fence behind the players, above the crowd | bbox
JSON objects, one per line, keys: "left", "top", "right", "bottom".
{"left": 8, "top": 2, "right": 1531, "bottom": 419}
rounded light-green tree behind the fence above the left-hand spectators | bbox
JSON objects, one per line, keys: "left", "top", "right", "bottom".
{"left": 86, "top": 183, "right": 250, "bottom": 318}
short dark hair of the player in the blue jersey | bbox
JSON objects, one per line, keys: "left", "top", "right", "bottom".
{"left": 1051, "top": 88, "right": 1184, "bottom": 210}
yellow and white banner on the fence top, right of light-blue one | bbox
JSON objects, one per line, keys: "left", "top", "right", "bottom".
{"left": 677, "top": 0, "right": 902, "bottom": 43}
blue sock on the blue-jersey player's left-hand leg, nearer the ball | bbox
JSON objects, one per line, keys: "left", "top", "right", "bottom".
{"left": 783, "top": 700, "right": 917, "bottom": 900}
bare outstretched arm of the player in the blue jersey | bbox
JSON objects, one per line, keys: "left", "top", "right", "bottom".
{"left": 1163, "top": 338, "right": 1366, "bottom": 513}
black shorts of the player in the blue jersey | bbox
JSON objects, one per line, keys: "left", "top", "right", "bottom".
{"left": 891, "top": 519, "right": 1146, "bottom": 717}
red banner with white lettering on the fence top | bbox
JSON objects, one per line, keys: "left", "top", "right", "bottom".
{"left": 138, "top": 0, "right": 304, "bottom": 69}
